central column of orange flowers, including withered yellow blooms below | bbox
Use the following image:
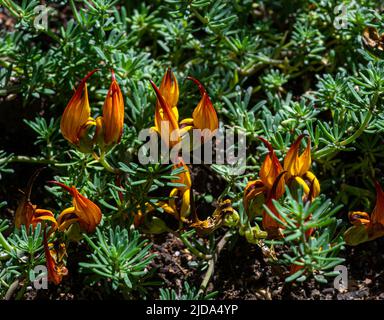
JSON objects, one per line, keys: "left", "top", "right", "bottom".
{"left": 135, "top": 69, "right": 234, "bottom": 233}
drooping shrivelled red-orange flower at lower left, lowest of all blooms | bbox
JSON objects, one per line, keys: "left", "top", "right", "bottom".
{"left": 43, "top": 230, "right": 68, "bottom": 285}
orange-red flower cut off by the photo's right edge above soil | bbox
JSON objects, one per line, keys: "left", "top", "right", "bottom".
{"left": 344, "top": 182, "right": 384, "bottom": 246}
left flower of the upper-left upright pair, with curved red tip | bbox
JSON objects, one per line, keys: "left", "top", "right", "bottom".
{"left": 60, "top": 69, "right": 97, "bottom": 152}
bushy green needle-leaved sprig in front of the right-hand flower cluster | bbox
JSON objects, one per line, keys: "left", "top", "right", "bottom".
{"left": 266, "top": 191, "right": 345, "bottom": 282}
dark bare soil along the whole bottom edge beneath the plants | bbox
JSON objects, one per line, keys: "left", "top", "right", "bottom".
{"left": 15, "top": 233, "right": 384, "bottom": 300}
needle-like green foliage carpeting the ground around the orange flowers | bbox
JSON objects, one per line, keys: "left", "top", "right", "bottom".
{"left": 0, "top": 0, "right": 384, "bottom": 299}
